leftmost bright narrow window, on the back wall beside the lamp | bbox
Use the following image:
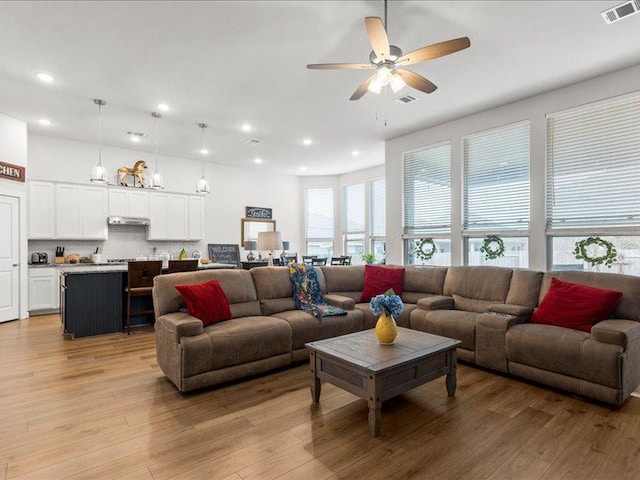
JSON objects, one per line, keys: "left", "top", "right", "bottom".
{"left": 305, "top": 187, "right": 334, "bottom": 257}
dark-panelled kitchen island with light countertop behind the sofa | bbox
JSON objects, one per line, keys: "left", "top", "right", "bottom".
{"left": 58, "top": 263, "right": 235, "bottom": 338}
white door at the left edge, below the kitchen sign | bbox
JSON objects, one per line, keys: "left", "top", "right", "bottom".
{"left": 0, "top": 195, "right": 20, "bottom": 322}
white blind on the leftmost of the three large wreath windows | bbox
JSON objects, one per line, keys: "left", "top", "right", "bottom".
{"left": 403, "top": 142, "right": 451, "bottom": 235}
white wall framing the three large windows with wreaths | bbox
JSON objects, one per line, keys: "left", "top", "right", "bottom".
{"left": 385, "top": 65, "right": 640, "bottom": 270}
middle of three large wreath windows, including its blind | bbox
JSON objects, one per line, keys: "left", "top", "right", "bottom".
{"left": 462, "top": 121, "right": 529, "bottom": 267}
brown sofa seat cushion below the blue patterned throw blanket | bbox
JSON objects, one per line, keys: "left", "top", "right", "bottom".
{"left": 273, "top": 308, "right": 363, "bottom": 350}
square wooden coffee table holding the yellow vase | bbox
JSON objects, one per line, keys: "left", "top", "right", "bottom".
{"left": 305, "top": 327, "right": 461, "bottom": 437}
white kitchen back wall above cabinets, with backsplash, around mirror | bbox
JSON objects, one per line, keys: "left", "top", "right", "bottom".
{"left": 28, "top": 135, "right": 302, "bottom": 257}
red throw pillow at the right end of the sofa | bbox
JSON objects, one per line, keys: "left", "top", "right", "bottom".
{"left": 531, "top": 278, "right": 622, "bottom": 333}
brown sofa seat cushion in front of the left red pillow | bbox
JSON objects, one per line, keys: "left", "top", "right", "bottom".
{"left": 180, "top": 316, "right": 291, "bottom": 377}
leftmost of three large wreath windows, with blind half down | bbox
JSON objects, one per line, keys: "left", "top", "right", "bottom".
{"left": 403, "top": 142, "right": 451, "bottom": 265}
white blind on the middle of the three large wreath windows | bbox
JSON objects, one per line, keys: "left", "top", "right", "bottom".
{"left": 462, "top": 121, "right": 529, "bottom": 234}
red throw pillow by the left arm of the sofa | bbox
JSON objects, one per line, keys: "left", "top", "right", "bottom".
{"left": 176, "top": 280, "right": 231, "bottom": 327}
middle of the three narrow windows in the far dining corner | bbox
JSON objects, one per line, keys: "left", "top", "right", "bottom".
{"left": 343, "top": 183, "right": 365, "bottom": 264}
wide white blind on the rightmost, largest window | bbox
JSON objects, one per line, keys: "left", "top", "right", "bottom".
{"left": 547, "top": 94, "right": 640, "bottom": 233}
